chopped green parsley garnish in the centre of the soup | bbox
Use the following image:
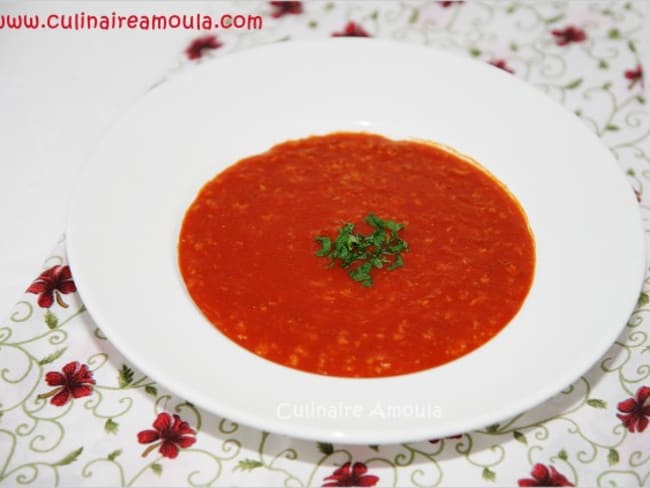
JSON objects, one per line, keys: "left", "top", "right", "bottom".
{"left": 316, "top": 214, "right": 408, "bottom": 287}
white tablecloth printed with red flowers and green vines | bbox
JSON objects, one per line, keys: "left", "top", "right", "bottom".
{"left": 0, "top": 0, "right": 650, "bottom": 486}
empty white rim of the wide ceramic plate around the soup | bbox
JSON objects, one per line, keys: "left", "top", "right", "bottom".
{"left": 67, "top": 39, "right": 644, "bottom": 444}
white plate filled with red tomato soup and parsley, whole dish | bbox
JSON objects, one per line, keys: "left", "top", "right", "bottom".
{"left": 66, "top": 39, "right": 645, "bottom": 444}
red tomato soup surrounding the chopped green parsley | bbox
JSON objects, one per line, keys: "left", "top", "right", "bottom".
{"left": 179, "top": 133, "right": 535, "bottom": 377}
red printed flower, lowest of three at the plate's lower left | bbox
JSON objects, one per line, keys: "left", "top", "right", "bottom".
{"left": 138, "top": 412, "right": 196, "bottom": 459}
